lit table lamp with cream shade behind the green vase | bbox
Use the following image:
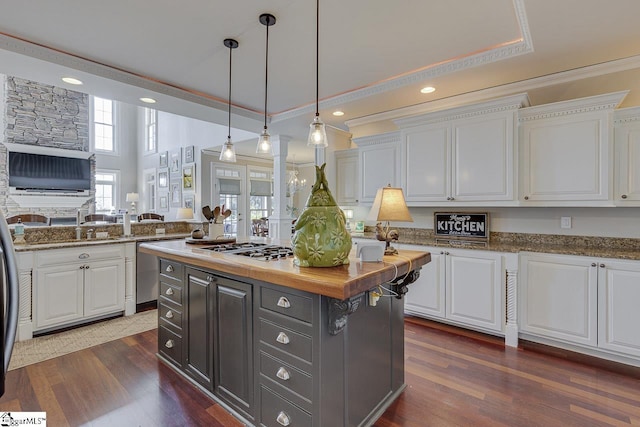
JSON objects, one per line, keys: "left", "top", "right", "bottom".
{"left": 367, "top": 184, "right": 413, "bottom": 255}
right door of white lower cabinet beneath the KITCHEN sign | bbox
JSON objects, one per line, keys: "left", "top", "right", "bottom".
{"left": 445, "top": 253, "right": 503, "bottom": 331}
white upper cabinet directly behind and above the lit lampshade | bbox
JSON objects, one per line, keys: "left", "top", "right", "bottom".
{"left": 353, "top": 132, "right": 400, "bottom": 203}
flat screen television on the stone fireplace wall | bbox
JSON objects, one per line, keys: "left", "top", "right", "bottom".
{"left": 8, "top": 151, "right": 91, "bottom": 193}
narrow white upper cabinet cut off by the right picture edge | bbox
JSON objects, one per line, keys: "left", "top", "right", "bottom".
{"left": 614, "top": 107, "right": 640, "bottom": 206}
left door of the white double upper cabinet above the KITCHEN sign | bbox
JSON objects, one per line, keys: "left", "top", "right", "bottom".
{"left": 403, "top": 125, "right": 451, "bottom": 202}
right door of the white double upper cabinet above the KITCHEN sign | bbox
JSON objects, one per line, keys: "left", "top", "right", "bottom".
{"left": 452, "top": 117, "right": 513, "bottom": 201}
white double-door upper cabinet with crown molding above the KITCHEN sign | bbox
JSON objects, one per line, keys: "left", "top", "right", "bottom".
{"left": 395, "top": 94, "right": 528, "bottom": 206}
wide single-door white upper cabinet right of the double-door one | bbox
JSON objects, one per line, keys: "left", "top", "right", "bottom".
{"left": 519, "top": 91, "right": 627, "bottom": 206}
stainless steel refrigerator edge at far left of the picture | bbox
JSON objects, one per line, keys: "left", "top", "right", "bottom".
{"left": 0, "top": 213, "right": 19, "bottom": 396}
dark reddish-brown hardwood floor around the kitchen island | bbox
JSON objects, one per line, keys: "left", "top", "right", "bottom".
{"left": 0, "top": 318, "right": 640, "bottom": 427}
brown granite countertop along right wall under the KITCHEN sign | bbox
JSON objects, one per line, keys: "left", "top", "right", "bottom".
{"left": 354, "top": 229, "right": 640, "bottom": 260}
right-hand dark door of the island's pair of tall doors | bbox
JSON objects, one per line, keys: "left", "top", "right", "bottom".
{"left": 215, "top": 278, "right": 253, "bottom": 416}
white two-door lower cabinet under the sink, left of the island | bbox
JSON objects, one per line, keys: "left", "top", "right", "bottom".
{"left": 33, "top": 244, "right": 125, "bottom": 331}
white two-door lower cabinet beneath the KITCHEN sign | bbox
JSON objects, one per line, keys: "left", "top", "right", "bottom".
{"left": 401, "top": 245, "right": 505, "bottom": 333}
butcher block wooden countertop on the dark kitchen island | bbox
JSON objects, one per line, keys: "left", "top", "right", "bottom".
{"left": 140, "top": 240, "right": 431, "bottom": 300}
